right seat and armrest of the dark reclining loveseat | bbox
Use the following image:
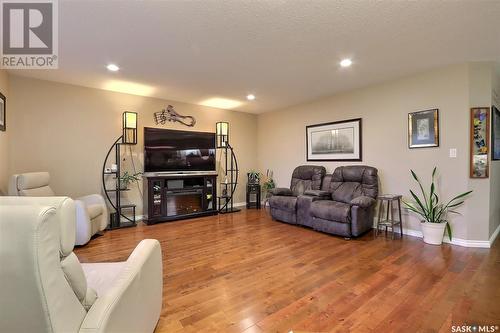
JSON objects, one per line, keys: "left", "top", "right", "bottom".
{"left": 310, "top": 166, "right": 378, "bottom": 238}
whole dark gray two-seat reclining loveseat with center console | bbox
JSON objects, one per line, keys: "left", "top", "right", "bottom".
{"left": 269, "top": 165, "right": 378, "bottom": 238}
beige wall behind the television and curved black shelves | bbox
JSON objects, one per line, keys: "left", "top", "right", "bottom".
{"left": 9, "top": 76, "right": 257, "bottom": 214}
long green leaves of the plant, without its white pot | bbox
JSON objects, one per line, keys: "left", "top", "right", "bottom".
{"left": 403, "top": 167, "right": 472, "bottom": 240}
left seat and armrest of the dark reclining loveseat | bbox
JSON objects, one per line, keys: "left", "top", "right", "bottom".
{"left": 269, "top": 165, "right": 326, "bottom": 224}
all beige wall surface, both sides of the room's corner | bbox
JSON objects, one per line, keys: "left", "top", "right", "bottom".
{"left": 5, "top": 63, "right": 500, "bottom": 240}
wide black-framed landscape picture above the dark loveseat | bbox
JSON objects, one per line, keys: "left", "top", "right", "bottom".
{"left": 306, "top": 118, "right": 361, "bottom": 161}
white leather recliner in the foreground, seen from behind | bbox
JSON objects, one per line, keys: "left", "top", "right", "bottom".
{"left": 0, "top": 197, "right": 163, "bottom": 333}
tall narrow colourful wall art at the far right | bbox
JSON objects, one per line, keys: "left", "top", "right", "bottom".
{"left": 470, "top": 108, "right": 490, "bottom": 178}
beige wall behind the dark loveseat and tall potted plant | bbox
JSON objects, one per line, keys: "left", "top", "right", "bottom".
{"left": 258, "top": 64, "right": 491, "bottom": 240}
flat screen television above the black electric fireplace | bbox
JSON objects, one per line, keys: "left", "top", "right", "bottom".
{"left": 144, "top": 127, "right": 215, "bottom": 172}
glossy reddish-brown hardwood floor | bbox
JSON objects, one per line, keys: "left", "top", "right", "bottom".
{"left": 76, "top": 206, "right": 500, "bottom": 332}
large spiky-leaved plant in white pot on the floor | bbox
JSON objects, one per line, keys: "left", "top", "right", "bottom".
{"left": 403, "top": 167, "right": 472, "bottom": 245}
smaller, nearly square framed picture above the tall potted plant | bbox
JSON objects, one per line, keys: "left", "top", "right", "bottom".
{"left": 408, "top": 109, "right": 439, "bottom": 149}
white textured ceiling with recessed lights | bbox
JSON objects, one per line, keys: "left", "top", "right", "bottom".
{"left": 12, "top": 0, "right": 500, "bottom": 113}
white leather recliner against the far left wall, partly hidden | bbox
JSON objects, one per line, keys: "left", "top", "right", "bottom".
{"left": 9, "top": 172, "right": 109, "bottom": 245}
